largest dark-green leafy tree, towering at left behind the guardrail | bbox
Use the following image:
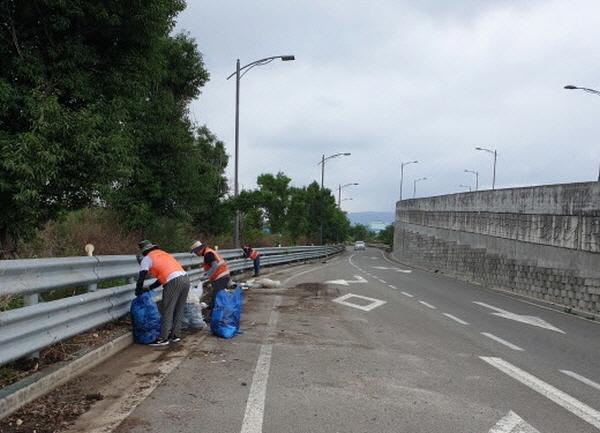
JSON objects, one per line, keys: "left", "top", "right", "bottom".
{"left": 0, "top": 0, "right": 195, "bottom": 255}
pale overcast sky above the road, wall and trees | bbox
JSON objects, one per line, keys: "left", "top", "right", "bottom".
{"left": 177, "top": 0, "right": 600, "bottom": 212}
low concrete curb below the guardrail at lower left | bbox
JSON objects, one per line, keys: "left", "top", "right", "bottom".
{"left": 0, "top": 332, "right": 133, "bottom": 419}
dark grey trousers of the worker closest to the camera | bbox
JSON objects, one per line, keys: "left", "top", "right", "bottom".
{"left": 160, "top": 275, "right": 190, "bottom": 340}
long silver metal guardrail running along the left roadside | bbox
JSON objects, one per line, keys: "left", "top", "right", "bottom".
{"left": 0, "top": 245, "right": 344, "bottom": 365}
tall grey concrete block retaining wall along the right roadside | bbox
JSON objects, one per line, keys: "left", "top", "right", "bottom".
{"left": 393, "top": 182, "right": 600, "bottom": 315}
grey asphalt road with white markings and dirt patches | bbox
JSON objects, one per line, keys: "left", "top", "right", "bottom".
{"left": 91, "top": 249, "right": 600, "bottom": 433}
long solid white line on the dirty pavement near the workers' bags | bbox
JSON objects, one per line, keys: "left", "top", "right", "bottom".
{"left": 241, "top": 296, "right": 281, "bottom": 433}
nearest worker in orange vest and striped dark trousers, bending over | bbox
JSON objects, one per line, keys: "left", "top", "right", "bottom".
{"left": 135, "top": 240, "right": 190, "bottom": 347}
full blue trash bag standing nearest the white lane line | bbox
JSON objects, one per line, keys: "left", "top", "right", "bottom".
{"left": 210, "top": 285, "right": 242, "bottom": 338}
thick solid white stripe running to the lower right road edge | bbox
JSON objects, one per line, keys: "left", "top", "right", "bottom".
{"left": 480, "top": 356, "right": 600, "bottom": 429}
